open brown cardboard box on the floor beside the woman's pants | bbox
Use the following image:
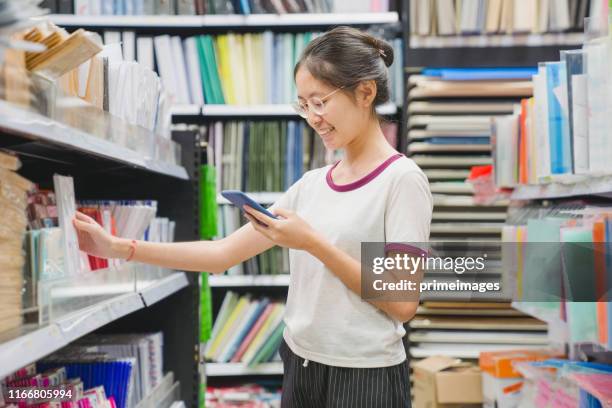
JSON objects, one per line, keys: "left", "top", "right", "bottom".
{"left": 413, "top": 356, "right": 482, "bottom": 408}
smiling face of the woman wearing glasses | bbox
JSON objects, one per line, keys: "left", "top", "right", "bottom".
{"left": 295, "top": 67, "right": 368, "bottom": 150}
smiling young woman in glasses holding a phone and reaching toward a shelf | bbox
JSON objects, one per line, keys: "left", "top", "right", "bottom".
{"left": 74, "top": 27, "right": 432, "bottom": 408}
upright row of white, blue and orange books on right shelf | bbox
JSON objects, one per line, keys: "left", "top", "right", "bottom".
{"left": 494, "top": 29, "right": 612, "bottom": 187}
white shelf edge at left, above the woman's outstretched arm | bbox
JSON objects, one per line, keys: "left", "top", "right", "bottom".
{"left": 0, "top": 101, "right": 189, "bottom": 180}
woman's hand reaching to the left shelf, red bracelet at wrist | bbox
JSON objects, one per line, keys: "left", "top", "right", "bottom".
{"left": 72, "top": 211, "right": 127, "bottom": 259}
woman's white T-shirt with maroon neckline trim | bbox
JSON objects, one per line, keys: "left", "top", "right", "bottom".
{"left": 272, "top": 154, "right": 433, "bottom": 368}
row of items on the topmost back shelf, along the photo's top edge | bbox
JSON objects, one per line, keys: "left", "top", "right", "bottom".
{"left": 51, "top": 0, "right": 395, "bottom": 15}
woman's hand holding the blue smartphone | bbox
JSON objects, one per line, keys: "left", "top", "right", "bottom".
{"left": 244, "top": 205, "right": 319, "bottom": 251}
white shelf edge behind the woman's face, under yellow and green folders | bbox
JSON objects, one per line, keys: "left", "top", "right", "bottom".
{"left": 202, "top": 103, "right": 397, "bottom": 118}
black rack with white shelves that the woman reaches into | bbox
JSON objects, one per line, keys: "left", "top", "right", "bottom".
{"left": 0, "top": 101, "right": 200, "bottom": 407}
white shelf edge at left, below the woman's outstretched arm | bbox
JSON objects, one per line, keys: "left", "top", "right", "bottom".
{"left": 0, "top": 272, "right": 187, "bottom": 379}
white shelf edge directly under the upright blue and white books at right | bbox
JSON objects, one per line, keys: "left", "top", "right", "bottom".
{"left": 511, "top": 176, "right": 612, "bottom": 200}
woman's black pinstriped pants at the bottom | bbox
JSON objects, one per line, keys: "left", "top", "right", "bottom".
{"left": 280, "top": 340, "right": 410, "bottom": 408}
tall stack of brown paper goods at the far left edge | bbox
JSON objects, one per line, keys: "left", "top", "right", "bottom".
{"left": 0, "top": 152, "right": 33, "bottom": 333}
